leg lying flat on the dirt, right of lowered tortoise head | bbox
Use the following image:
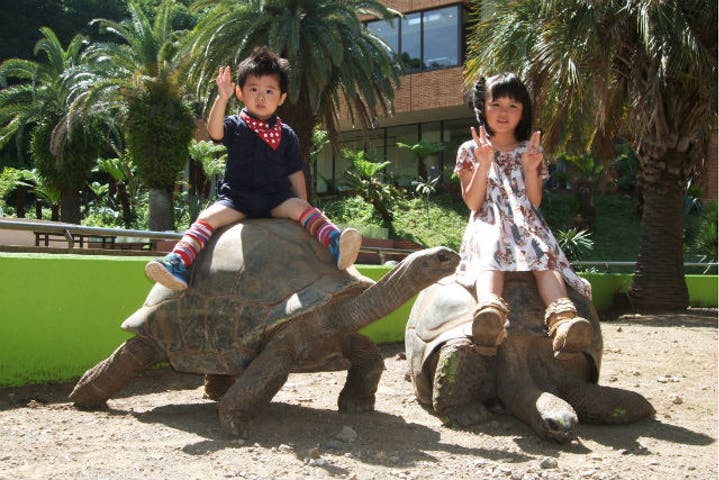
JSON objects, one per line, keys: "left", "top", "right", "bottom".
{"left": 559, "top": 381, "right": 655, "bottom": 425}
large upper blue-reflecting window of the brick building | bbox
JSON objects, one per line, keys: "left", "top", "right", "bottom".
{"left": 366, "top": 5, "right": 465, "bottom": 73}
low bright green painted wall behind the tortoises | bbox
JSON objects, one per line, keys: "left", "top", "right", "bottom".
{"left": 0, "top": 253, "right": 717, "bottom": 387}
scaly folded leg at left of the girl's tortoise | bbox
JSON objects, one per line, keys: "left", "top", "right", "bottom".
{"left": 432, "top": 338, "right": 494, "bottom": 427}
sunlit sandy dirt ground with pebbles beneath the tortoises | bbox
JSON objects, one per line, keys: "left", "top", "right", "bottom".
{"left": 0, "top": 311, "right": 717, "bottom": 480}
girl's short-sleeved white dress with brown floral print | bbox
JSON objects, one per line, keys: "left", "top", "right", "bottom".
{"left": 455, "top": 140, "right": 592, "bottom": 300}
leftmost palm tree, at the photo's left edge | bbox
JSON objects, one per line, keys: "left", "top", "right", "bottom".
{"left": 0, "top": 27, "right": 103, "bottom": 223}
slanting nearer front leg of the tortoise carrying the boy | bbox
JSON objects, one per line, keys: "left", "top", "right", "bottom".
{"left": 218, "top": 341, "right": 294, "bottom": 437}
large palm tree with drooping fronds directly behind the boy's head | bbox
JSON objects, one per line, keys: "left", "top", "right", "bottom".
{"left": 183, "top": 0, "right": 400, "bottom": 197}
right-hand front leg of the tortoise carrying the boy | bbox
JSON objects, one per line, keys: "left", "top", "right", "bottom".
{"left": 337, "top": 334, "right": 384, "bottom": 413}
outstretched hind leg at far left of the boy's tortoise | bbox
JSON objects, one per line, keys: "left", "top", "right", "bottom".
{"left": 68, "top": 337, "right": 167, "bottom": 409}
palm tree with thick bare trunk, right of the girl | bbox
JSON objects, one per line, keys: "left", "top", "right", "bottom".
{"left": 466, "top": 0, "right": 717, "bottom": 310}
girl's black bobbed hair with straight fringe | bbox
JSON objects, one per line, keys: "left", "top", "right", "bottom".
{"left": 472, "top": 73, "right": 532, "bottom": 142}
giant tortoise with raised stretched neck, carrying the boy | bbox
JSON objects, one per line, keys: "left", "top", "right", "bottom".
{"left": 70, "top": 219, "right": 459, "bottom": 435}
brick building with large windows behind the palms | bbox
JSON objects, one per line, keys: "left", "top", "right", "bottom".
{"left": 315, "top": 0, "right": 475, "bottom": 194}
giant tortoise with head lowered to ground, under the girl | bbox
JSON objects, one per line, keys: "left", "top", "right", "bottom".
{"left": 405, "top": 272, "right": 654, "bottom": 443}
